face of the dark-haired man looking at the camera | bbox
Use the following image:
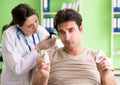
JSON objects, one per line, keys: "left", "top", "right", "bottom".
{"left": 58, "top": 21, "right": 82, "bottom": 49}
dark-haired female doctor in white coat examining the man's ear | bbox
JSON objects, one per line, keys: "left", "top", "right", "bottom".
{"left": 1, "top": 4, "right": 56, "bottom": 85}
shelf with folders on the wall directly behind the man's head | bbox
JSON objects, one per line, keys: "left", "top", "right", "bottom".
{"left": 40, "top": 0, "right": 80, "bottom": 32}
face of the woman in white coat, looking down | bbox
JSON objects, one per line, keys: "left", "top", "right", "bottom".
{"left": 18, "top": 15, "right": 38, "bottom": 36}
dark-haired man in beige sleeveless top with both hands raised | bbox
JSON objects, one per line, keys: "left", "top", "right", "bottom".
{"left": 32, "top": 9, "right": 116, "bottom": 85}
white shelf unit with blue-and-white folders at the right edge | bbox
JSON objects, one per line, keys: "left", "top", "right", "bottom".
{"left": 111, "top": 0, "right": 120, "bottom": 69}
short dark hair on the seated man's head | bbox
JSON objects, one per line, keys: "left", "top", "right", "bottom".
{"left": 54, "top": 9, "right": 82, "bottom": 30}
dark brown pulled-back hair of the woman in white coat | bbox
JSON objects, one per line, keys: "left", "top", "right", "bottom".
{"left": 9, "top": 4, "right": 37, "bottom": 26}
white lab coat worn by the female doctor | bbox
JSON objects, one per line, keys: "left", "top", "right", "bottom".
{"left": 1, "top": 26, "right": 49, "bottom": 85}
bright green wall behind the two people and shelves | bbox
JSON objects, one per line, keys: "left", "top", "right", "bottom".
{"left": 0, "top": 0, "right": 120, "bottom": 80}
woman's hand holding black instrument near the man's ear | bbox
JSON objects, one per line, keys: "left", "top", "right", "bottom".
{"left": 35, "top": 37, "right": 56, "bottom": 52}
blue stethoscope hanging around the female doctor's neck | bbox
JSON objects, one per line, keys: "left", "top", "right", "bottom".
{"left": 16, "top": 27, "right": 40, "bottom": 51}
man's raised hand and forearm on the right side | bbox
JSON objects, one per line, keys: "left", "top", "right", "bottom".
{"left": 96, "top": 56, "right": 116, "bottom": 85}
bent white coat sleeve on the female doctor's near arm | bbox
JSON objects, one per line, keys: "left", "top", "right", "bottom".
{"left": 2, "top": 32, "right": 39, "bottom": 75}
